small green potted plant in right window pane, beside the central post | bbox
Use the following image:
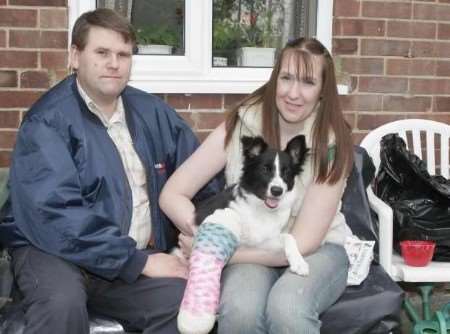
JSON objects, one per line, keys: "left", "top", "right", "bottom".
{"left": 212, "top": 19, "right": 241, "bottom": 66}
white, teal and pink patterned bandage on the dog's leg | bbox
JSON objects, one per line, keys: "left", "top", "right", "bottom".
{"left": 178, "top": 209, "right": 240, "bottom": 334}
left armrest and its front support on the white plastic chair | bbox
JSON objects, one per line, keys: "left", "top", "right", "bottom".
{"left": 367, "top": 186, "right": 393, "bottom": 278}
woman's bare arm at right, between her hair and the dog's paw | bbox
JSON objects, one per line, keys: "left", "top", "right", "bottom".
{"left": 291, "top": 178, "right": 346, "bottom": 255}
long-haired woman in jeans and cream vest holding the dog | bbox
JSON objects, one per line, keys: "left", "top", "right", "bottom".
{"left": 160, "top": 38, "right": 353, "bottom": 334}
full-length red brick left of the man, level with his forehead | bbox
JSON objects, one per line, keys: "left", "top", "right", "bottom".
{"left": 9, "top": 30, "right": 67, "bottom": 49}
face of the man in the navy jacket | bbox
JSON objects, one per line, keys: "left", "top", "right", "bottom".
{"left": 71, "top": 26, "right": 133, "bottom": 104}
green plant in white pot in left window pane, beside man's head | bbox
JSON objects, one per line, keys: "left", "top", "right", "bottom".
{"left": 136, "top": 25, "right": 179, "bottom": 54}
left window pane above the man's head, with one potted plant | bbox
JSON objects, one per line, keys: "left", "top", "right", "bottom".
{"left": 97, "top": 0, "right": 185, "bottom": 55}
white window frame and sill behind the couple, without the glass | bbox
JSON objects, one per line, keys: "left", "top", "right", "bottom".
{"left": 68, "top": 0, "right": 333, "bottom": 94}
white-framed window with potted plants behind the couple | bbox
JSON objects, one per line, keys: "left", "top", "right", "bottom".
{"left": 69, "top": 0, "right": 332, "bottom": 93}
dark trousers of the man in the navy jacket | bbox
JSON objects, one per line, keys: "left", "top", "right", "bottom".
{"left": 11, "top": 246, "right": 186, "bottom": 334}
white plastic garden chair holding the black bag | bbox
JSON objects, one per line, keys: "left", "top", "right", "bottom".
{"left": 361, "top": 119, "right": 450, "bottom": 282}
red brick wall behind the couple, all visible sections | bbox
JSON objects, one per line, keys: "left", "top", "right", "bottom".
{"left": 0, "top": 0, "right": 450, "bottom": 167}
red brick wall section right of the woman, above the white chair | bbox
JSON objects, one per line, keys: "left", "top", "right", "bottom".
{"left": 333, "top": 0, "right": 450, "bottom": 142}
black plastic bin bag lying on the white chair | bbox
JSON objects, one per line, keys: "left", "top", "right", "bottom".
{"left": 374, "top": 134, "right": 450, "bottom": 261}
